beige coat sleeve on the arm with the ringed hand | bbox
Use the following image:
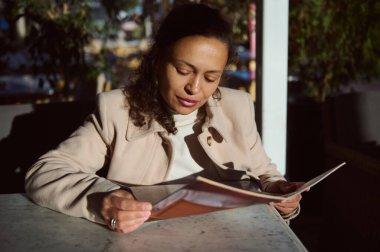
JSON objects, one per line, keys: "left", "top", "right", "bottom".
{"left": 25, "top": 92, "right": 119, "bottom": 223}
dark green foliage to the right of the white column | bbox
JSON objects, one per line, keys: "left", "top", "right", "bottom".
{"left": 289, "top": 0, "right": 380, "bottom": 102}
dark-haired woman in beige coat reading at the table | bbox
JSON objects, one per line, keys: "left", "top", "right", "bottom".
{"left": 26, "top": 4, "right": 301, "bottom": 233}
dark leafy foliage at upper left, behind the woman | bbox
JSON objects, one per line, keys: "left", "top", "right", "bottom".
{"left": 7, "top": 0, "right": 137, "bottom": 98}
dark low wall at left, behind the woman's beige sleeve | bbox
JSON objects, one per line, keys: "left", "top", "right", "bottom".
{"left": 0, "top": 102, "right": 94, "bottom": 193}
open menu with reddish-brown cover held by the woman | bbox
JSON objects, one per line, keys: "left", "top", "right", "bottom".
{"left": 151, "top": 163, "right": 345, "bottom": 220}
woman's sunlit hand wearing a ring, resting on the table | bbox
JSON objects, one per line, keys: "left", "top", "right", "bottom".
{"left": 101, "top": 189, "right": 152, "bottom": 233}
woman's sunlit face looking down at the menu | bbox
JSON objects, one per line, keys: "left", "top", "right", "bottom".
{"left": 157, "top": 36, "right": 228, "bottom": 115}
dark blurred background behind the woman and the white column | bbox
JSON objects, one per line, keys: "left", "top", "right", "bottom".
{"left": 0, "top": 0, "right": 380, "bottom": 251}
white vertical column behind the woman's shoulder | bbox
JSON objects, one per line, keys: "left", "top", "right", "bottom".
{"left": 262, "top": 0, "right": 289, "bottom": 174}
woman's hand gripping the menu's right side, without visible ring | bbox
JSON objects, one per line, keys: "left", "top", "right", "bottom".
{"left": 266, "top": 180, "right": 304, "bottom": 215}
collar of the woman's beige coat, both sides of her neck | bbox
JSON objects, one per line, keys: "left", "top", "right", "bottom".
{"left": 126, "top": 97, "right": 228, "bottom": 142}
